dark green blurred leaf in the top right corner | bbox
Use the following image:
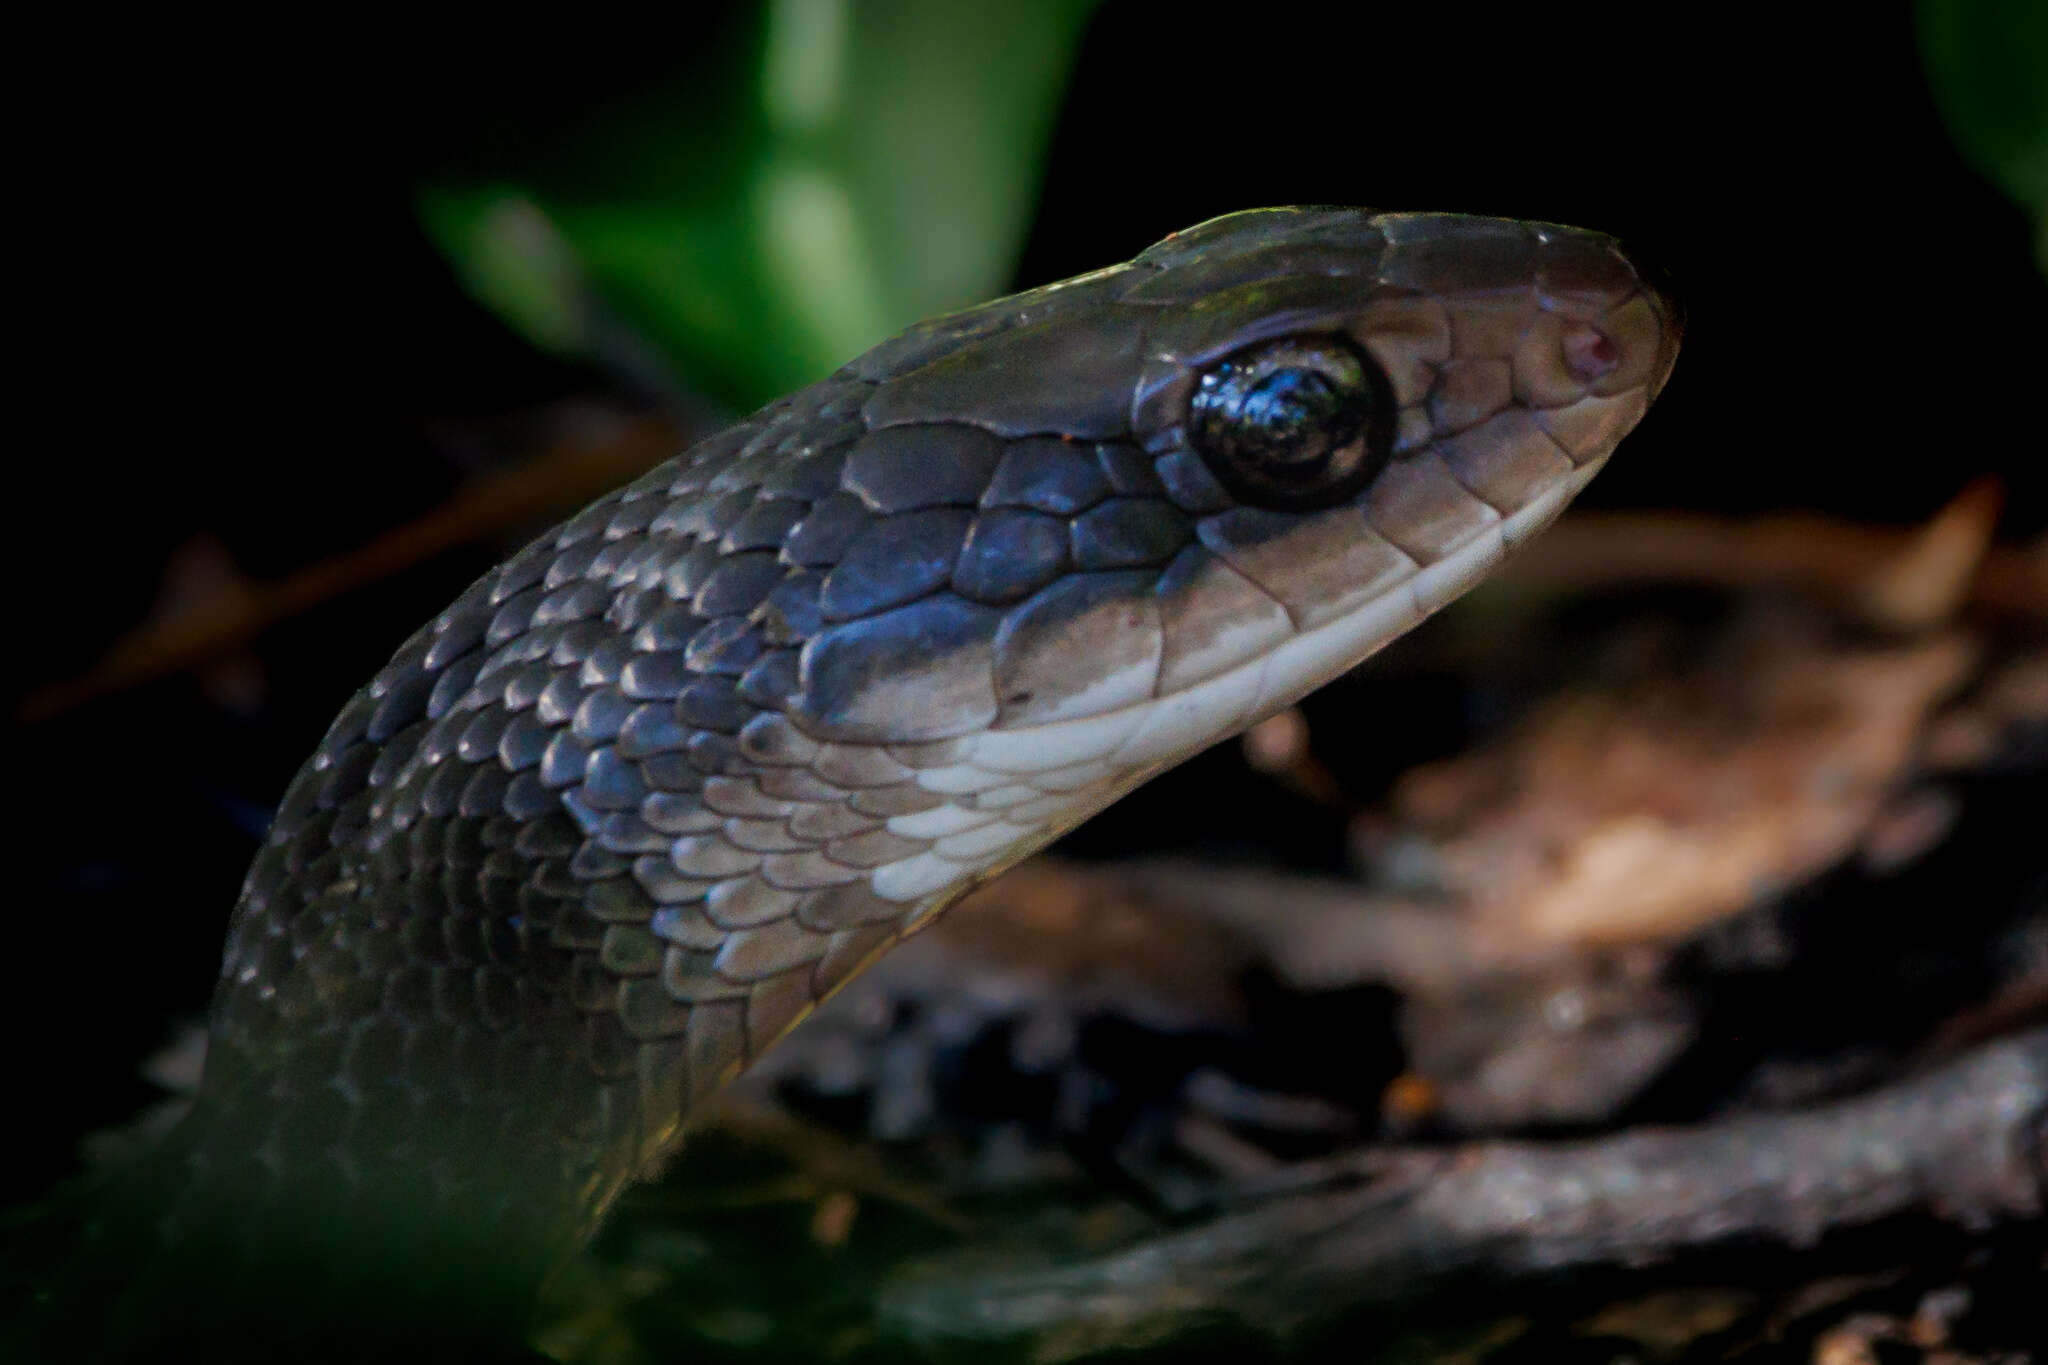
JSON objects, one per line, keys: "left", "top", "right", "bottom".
{"left": 1917, "top": 0, "right": 2048, "bottom": 272}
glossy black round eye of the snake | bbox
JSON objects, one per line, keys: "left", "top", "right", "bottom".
{"left": 1188, "top": 336, "right": 1395, "bottom": 510}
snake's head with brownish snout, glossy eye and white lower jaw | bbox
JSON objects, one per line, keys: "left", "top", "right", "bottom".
{"left": 791, "top": 209, "right": 1679, "bottom": 774}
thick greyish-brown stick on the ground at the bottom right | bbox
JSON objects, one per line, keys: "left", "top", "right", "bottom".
{"left": 883, "top": 1029, "right": 2048, "bottom": 1361}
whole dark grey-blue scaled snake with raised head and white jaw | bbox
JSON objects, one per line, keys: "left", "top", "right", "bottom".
{"left": 14, "top": 207, "right": 1681, "bottom": 1359}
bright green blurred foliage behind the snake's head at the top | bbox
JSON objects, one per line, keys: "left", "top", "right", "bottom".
{"left": 418, "top": 0, "right": 1094, "bottom": 407}
